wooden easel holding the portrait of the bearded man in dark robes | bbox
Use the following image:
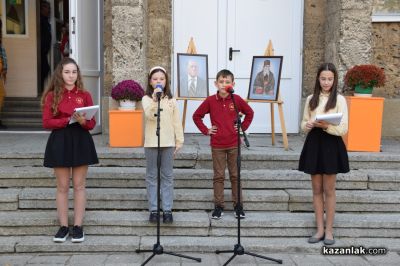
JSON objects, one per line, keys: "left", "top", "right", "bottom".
{"left": 247, "top": 40, "right": 289, "bottom": 151}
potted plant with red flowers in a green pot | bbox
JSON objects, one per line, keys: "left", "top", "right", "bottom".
{"left": 344, "top": 65, "right": 386, "bottom": 97}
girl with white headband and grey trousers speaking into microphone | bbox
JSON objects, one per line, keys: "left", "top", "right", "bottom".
{"left": 142, "top": 66, "right": 184, "bottom": 223}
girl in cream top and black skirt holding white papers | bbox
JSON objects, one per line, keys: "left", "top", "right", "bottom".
{"left": 299, "top": 63, "right": 349, "bottom": 245}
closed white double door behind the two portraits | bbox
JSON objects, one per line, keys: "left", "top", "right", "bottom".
{"left": 173, "top": 0, "right": 303, "bottom": 133}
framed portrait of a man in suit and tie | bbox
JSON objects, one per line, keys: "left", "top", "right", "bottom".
{"left": 177, "top": 53, "right": 208, "bottom": 98}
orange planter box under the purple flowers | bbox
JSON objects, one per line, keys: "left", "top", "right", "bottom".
{"left": 108, "top": 110, "right": 144, "bottom": 147}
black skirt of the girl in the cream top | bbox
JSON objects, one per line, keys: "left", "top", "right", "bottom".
{"left": 299, "top": 128, "right": 350, "bottom": 175}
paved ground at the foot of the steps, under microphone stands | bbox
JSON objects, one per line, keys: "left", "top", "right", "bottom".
{"left": 0, "top": 251, "right": 400, "bottom": 266}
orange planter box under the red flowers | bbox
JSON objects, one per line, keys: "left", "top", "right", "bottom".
{"left": 343, "top": 96, "right": 385, "bottom": 152}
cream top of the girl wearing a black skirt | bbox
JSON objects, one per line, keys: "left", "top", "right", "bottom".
{"left": 301, "top": 93, "right": 349, "bottom": 136}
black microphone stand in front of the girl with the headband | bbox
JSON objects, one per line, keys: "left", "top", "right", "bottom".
{"left": 136, "top": 93, "right": 201, "bottom": 266}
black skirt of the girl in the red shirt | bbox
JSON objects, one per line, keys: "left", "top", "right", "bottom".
{"left": 43, "top": 123, "right": 99, "bottom": 168}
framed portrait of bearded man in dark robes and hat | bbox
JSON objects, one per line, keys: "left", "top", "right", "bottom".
{"left": 247, "top": 56, "right": 283, "bottom": 101}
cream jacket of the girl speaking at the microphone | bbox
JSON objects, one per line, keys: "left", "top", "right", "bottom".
{"left": 142, "top": 95, "right": 184, "bottom": 147}
